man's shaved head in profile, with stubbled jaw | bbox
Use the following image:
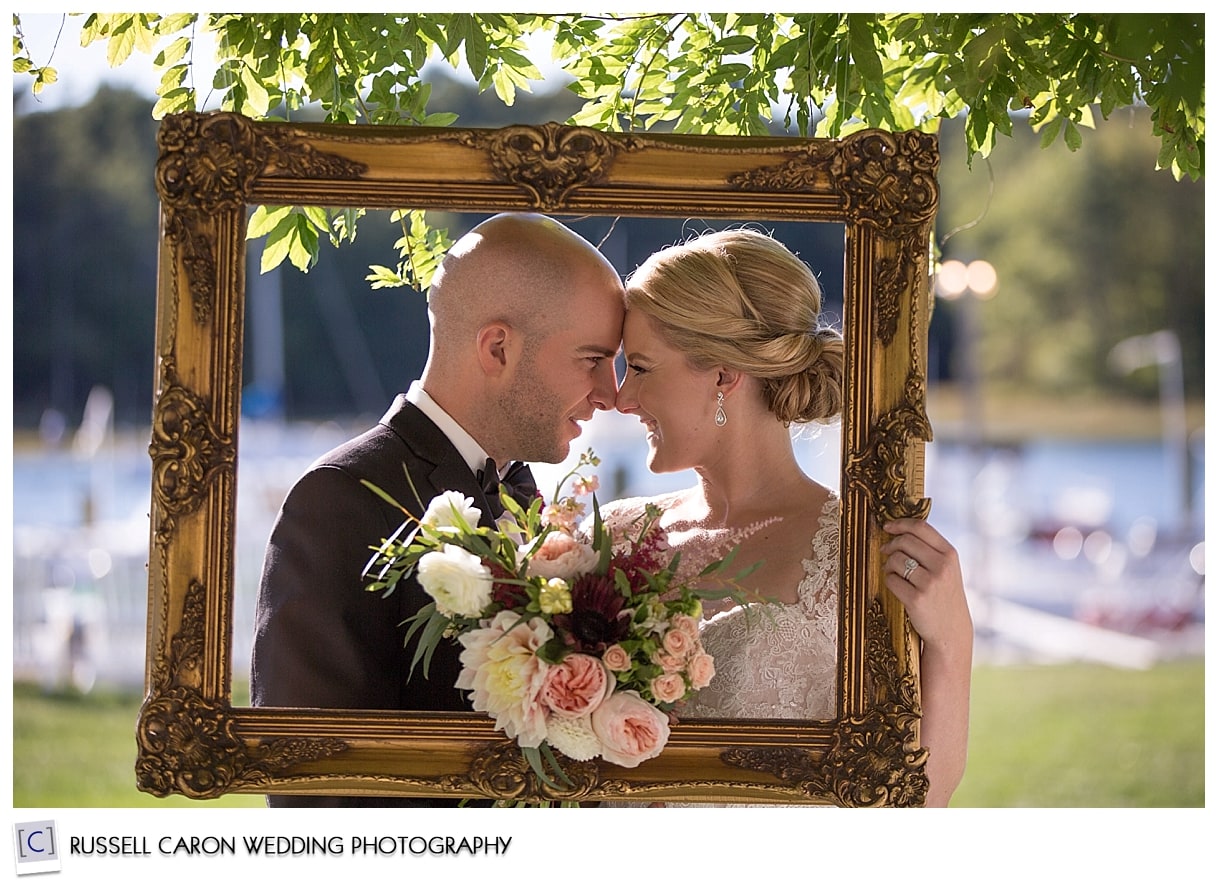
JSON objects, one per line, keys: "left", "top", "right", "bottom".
{"left": 421, "top": 213, "right": 626, "bottom": 463}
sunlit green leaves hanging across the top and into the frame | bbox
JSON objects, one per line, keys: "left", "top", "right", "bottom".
{"left": 13, "top": 12, "right": 1205, "bottom": 280}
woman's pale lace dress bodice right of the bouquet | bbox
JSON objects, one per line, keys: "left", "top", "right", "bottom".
{"left": 603, "top": 495, "right": 840, "bottom": 720}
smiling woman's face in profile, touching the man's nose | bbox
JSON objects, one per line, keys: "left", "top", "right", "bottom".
{"left": 618, "top": 309, "right": 716, "bottom": 473}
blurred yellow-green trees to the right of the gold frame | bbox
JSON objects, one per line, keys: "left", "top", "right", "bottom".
{"left": 932, "top": 108, "right": 1205, "bottom": 398}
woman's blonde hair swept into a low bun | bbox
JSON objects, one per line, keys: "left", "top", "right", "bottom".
{"left": 626, "top": 229, "right": 845, "bottom": 425}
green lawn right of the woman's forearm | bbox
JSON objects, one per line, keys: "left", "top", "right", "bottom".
{"left": 951, "top": 659, "right": 1206, "bottom": 808}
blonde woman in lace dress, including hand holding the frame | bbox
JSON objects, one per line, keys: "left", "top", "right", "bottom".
{"left": 603, "top": 229, "right": 973, "bottom": 805}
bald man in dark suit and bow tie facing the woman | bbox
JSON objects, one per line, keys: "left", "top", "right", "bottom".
{"left": 250, "top": 213, "right": 624, "bottom": 806}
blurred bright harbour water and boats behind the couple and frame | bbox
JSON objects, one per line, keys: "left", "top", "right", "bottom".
{"left": 13, "top": 402, "right": 1205, "bottom": 690}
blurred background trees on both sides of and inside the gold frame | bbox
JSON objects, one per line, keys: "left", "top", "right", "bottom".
{"left": 13, "top": 76, "right": 1205, "bottom": 429}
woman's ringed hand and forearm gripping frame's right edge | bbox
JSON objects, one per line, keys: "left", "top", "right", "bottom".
{"left": 881, "top": 519, "right": 973, "bottom": 806}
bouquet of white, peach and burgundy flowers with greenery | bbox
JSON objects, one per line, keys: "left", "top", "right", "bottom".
{"left": 368, "top": 451, "right": 744, "bottom": 781}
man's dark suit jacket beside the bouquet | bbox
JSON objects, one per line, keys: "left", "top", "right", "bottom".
{"left": 250, "top": 396, "right": 493, "bottom": 806}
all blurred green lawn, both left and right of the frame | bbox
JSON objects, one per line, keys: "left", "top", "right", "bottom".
{"left": 13, "top": 659, "right": 1205, "bottom": 808}
